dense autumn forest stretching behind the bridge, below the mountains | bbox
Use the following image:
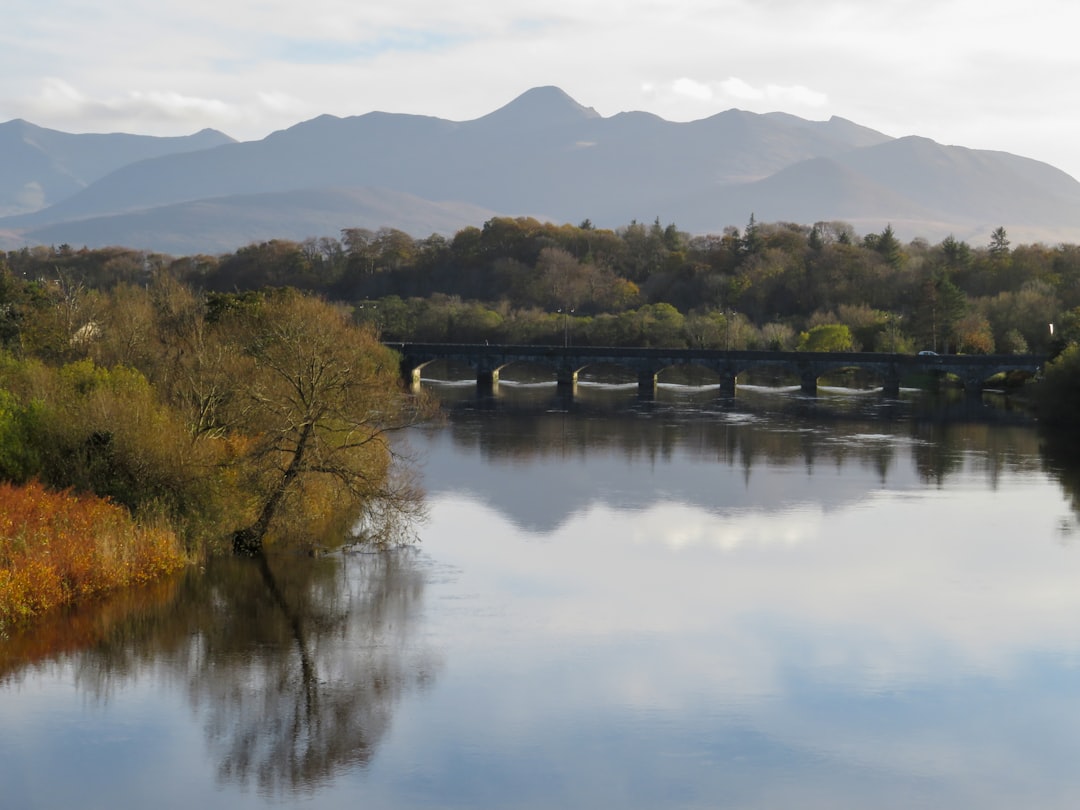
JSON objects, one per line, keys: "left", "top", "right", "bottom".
{"left": 8, "top": 216, "right": 1080, "bottom": 353}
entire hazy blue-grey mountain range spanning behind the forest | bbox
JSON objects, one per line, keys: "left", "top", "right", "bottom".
{"left": 0, "top": 87, "right": 1080, "bottom": 255}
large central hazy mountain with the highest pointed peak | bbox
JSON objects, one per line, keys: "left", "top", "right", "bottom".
{"left": 3, "top": 87, "right": 885, "bottom": 228}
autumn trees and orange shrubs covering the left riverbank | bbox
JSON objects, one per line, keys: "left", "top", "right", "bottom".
{"left": 0, "top": 273, "right": 431, "bottom": 632}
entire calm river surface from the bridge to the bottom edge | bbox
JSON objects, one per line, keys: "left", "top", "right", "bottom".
{"left": 0, "top": 383, "right": 1080, "bottom": 810}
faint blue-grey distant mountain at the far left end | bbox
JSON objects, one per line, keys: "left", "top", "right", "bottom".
{"left": 0, "top": 119, "right": 232, "bottom": 215}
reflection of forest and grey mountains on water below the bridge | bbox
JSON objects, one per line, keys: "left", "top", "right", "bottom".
{"left": 416, "top": 386, "right": 1040, "bottom": 531}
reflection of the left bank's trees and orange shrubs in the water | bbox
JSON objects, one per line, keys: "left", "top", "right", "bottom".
{"left": 0, "top": 550, "right": 440, "bottom": 795}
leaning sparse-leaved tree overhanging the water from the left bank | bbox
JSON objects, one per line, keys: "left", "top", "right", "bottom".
{"left": 221, "top": 293, "right": 432, "bottom": 554}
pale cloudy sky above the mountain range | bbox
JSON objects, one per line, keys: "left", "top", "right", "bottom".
{"left": 6, "top": 0, "right": 1080, "bottom": 178}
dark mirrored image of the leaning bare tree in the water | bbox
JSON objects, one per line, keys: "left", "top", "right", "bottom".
{"left": 184, "top": 552, "right": 436, "bottom": 793}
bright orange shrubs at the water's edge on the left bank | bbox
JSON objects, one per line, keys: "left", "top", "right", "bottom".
{"left": 0, "top": 483, "right": 184, "bottom": 630}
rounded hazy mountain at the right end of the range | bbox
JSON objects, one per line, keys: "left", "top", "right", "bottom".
{"left": 665, "top": 144, "right": 1080, "bottom": 244}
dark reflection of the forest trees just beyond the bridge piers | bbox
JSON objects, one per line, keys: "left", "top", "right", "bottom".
{"left": 440, "top": 395, "right": 1037, "bottom": 484}
